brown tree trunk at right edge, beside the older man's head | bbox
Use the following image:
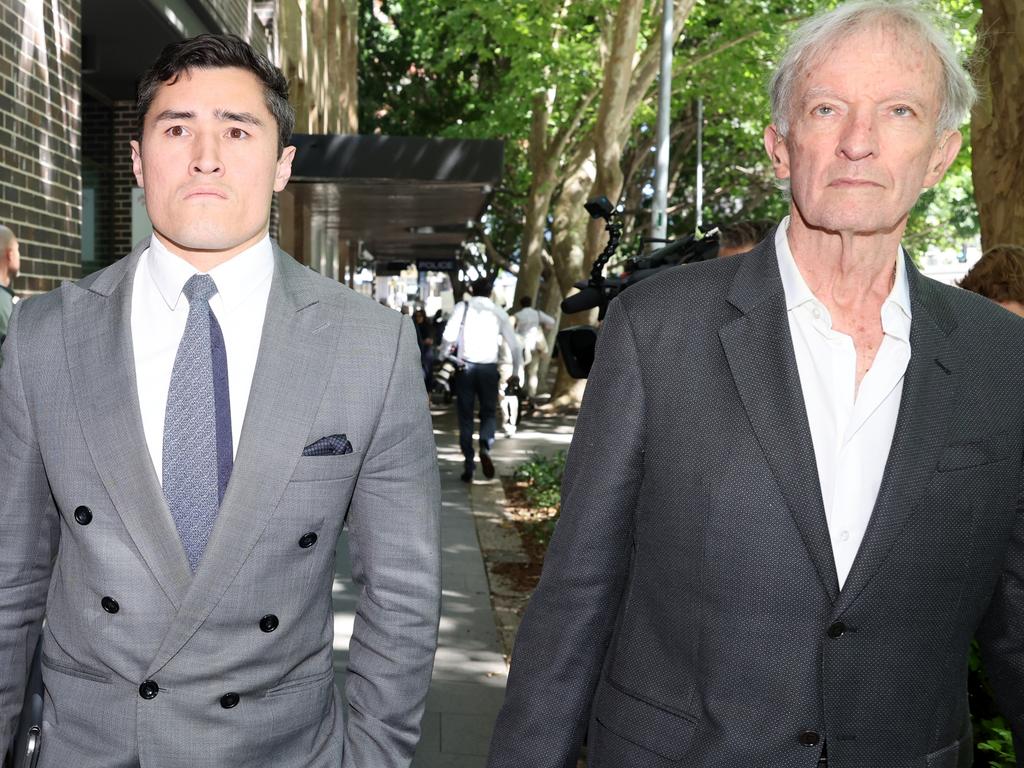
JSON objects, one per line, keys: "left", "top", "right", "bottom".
{"left": 971, "top": 0, "right": 1024, "bottom": 250}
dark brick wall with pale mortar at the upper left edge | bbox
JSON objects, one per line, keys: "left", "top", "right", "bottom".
{"left": 0, "top": 0, "right": 82, "bottom": 293}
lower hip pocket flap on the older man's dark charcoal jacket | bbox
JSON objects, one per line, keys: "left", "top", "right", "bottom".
{"left": 595, "top": 680, "right": 696, "bottom": 760}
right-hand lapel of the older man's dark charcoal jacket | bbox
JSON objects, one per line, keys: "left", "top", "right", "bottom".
{"left": 835, "top": 258, "right": 959, "bottom": 615}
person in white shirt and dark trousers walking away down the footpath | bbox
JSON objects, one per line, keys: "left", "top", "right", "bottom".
{"left": 441, "top": 278, "right": 522, "bottom": 482}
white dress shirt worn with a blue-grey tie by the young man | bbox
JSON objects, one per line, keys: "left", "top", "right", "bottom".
{"left": 131, "top": 234, "right": 273, "bottom": 482}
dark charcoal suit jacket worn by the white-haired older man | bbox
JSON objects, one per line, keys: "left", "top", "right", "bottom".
{"left": 488, "top": 237, "right": 1024, "bottom": 768}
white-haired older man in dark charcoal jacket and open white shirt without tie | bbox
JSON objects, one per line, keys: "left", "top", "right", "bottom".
{"left": 488, "top": 0, "right": 1024, "bottom": 768}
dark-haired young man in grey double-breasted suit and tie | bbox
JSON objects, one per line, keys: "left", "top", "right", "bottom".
{"left": 0, "top": 36, "right": 440, "bottom": 768}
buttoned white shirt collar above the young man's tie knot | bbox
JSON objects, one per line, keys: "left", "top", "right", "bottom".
{"left": 146, "top": 232, "right": 273, "bottom": 311}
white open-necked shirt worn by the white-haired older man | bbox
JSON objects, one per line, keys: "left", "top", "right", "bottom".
{"left": 775, "top": 217, "right": 910, "bottom": 588}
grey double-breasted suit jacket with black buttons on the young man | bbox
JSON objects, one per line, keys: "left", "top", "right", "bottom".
{"left": 0, "top": 244, "right": 440, "bottom": 768}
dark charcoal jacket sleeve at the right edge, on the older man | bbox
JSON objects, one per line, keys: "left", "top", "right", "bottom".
{"left": 977, "top": 450, "right": 1024, "bottom": 768}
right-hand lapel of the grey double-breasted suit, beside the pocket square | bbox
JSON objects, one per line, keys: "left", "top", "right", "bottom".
{"left": 148, "top": 250, "right": 338, "bottom": 675}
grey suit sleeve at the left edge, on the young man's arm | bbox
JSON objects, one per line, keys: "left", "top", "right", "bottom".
{"left": 0, "top": 304, "right": 59, "bottom": 758}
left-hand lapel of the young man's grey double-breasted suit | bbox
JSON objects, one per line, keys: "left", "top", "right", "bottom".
{"left": 62, "top": 241, "right": 191, "bottom": 608}
